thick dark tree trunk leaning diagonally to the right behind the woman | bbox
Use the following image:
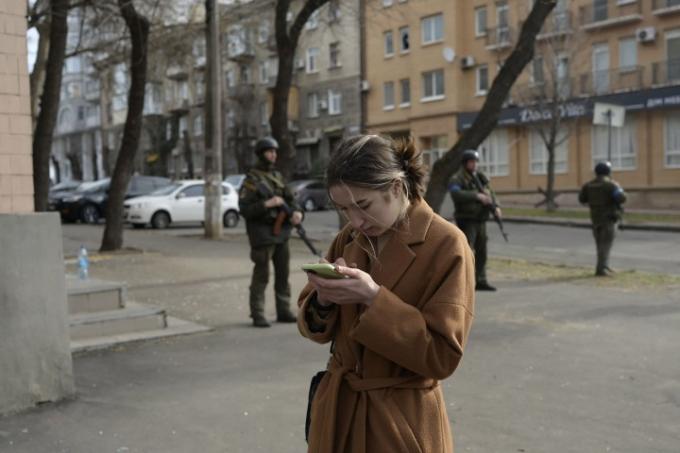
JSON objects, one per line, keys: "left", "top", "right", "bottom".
{"left": 425, "top": 0, "right": 557, "bottom": 212}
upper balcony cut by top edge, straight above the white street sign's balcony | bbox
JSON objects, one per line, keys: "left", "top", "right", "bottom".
{"left": 579, "top": 0, "right": 642, "bottom": 31}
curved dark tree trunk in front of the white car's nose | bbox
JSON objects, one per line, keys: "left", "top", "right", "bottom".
{"left": 100, "top": 0, "right": 149, "bottom": 251}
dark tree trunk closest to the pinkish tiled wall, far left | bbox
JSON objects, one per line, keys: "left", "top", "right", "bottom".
{"left": 33, "top": 0, "right": 68, "bottom": 211}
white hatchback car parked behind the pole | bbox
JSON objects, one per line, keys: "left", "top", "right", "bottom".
{"left": 123, "top": 179, "right": 239, "bottom": 229}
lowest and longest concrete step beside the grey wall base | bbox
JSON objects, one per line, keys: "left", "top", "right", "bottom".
{"left": 71, "top": 316, "right": 212, "bottom": 353}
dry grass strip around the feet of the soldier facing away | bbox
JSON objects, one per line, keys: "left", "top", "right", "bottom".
{"left": 488, "top": 258, "right": 680, "bottom": 291}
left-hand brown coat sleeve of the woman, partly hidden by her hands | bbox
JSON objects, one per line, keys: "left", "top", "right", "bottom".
{"left": 298, "top": 228, "right": 349, "bottom": 343}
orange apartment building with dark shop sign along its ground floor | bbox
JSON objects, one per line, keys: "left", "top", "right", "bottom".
{"left": 366, "top": 0, "right": 680, "bottom": 208}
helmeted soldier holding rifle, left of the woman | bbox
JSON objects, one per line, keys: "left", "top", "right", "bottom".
{"left": 239, "top": 137, "right": 302, "bottom": 327}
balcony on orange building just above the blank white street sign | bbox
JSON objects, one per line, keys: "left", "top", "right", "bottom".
{"left": 575, "top": 66, "right": 644, "bottom": 97}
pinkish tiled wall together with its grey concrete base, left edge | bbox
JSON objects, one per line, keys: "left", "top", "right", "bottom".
{"left": 0, "top": 0, "right": 74, "bottom": 414}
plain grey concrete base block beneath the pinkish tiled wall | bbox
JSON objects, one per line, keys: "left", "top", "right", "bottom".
{"left": 0, "top": 213, "right": 74, "bottom": 413}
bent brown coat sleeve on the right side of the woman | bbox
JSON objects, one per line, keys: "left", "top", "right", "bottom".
{"left": 350, "top": 234, "right": 475, "bottom": 379}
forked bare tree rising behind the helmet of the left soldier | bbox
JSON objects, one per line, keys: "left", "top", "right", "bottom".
{"left": 269, "top": 0, "right": 330, "bottom": 177}
